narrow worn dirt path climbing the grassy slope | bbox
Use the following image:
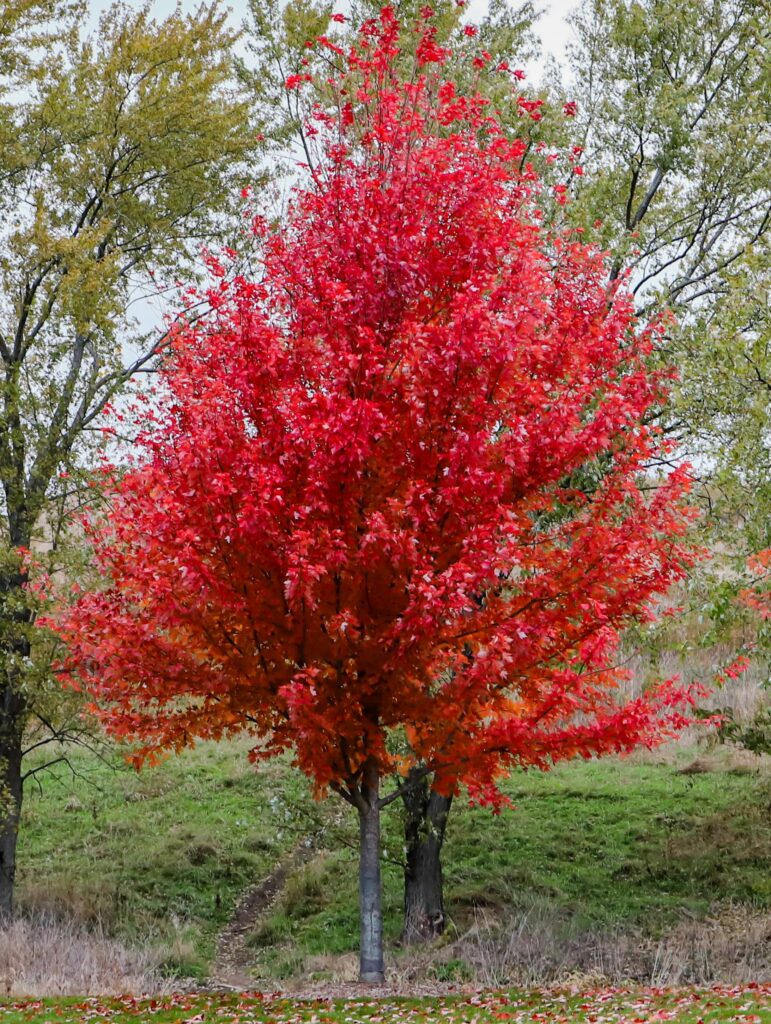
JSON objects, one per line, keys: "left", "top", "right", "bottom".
{"left": 209, "top": 843, "right": 315, "bottom": 991}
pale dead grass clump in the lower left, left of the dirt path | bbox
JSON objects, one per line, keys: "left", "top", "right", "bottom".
{"left": 0, "top": 914, "right": 173, "bottom": 997}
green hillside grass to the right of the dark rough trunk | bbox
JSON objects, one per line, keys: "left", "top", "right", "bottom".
{"left": 438, "top": 761, "right": 771, "bottom": 927}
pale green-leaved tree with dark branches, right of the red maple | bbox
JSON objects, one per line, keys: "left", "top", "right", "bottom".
{"left": 552, "top": 0, "right": 771, "bottom": 550}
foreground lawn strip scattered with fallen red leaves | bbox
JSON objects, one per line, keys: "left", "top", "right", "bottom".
{"left": 0, "top": 985, "right": 771, "bottom": 1024}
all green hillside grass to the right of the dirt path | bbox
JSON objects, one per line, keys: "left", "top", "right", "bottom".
{"left": 251, "top": 760, "right": 771, "bottom": 979}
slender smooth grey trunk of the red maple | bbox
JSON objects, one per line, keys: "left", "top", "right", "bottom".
{"left": 358, "top": 761, "right": 385, "bottom": 984}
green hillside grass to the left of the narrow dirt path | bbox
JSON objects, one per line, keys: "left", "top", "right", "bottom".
{"left": 18, "top": 744, "right": 310, "bottom": 976}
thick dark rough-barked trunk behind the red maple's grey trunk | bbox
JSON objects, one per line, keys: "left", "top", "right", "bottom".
{"left": 401, "top": 777, "right": 453, "bottom": 945}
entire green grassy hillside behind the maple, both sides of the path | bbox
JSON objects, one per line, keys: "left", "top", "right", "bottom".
{"left": 13, "top": 743, "right": 771, "bottom": 981}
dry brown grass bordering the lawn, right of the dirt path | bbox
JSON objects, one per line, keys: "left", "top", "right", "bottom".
{"left": 270, "top": 903, "right": 771, "bottom": 992}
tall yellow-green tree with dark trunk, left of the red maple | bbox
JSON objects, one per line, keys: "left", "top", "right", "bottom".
{"left": 0, "top": 2, "right": 255, "bottom": 912}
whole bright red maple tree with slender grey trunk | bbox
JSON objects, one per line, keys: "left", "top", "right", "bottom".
{"left": 46, "top": 8, "right": 692, "bottom": 980}
